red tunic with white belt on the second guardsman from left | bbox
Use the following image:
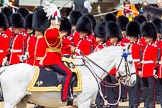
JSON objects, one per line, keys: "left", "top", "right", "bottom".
{"left": 9, "top": 32, "right": 26, "bottom": 64}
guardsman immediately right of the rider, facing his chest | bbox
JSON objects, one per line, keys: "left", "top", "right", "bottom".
{"left": 59, "top": 17, "right": 73, "bottom": 57}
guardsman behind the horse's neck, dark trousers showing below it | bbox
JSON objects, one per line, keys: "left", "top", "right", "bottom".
{"left": 105, "top": 21, "right": 124, "bottom": 108}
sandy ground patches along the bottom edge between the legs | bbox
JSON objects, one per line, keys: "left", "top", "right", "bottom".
{"left": 0, "top": 102, "right": 161, "bottom": 108}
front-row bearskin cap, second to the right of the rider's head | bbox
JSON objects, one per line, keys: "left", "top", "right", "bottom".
{"left": 76, "top": 16, "right": 92, "bottom": 35}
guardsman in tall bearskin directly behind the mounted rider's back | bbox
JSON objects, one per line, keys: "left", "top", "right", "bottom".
{"left": 31, "top": 8, "right": 49, "bottom": 66}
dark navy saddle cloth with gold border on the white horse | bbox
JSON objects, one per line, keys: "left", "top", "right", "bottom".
{"left": 27, "top": 57, "right": 82, "bottom": 92}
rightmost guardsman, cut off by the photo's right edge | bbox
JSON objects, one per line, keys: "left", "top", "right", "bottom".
{"left": 152, "top": 18, "right": 162, "bottom": 107}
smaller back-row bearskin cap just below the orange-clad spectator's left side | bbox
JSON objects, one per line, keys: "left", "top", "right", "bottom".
{"left": 117, "top": 15, "right": 129, "bottom": 31}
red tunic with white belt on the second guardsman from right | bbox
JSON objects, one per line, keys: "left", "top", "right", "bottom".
{"left": 139, "top": 44, "right": 157, "bottom": 77}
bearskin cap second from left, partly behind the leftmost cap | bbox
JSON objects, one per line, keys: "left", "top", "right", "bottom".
{"left": 2, "top": 7, "right": 13, "bottom": 26}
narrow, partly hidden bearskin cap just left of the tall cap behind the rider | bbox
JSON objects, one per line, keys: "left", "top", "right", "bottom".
{"left": 24, "top": 14, "right": 33, "bottom": 29}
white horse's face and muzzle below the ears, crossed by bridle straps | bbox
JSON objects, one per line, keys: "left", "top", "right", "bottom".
{"left": 117, "top": 48, "right": 136, "bottom": 86}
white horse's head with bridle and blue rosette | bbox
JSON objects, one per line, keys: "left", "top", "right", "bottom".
{"left": 116, "top": 45, "right": 136, "bottom": 86}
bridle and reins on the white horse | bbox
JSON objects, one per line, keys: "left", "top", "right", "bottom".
{"left": 78, "top": 44, "right": 136, "bottom": 87}
